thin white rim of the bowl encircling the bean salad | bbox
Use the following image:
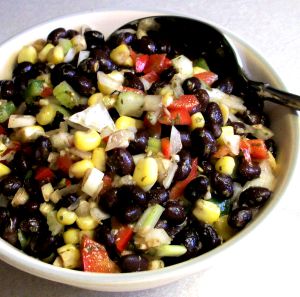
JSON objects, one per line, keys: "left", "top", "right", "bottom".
{"left": 0, "top": 9, "right": 299, "bottom": 291}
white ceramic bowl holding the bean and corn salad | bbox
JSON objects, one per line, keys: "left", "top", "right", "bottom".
{"left": 0, "top": 11, "right": 299, "bottom": 291}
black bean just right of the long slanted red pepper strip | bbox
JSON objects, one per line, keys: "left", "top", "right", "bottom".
{"left": 184, "top": 175, "right": 209, "bottom": 202}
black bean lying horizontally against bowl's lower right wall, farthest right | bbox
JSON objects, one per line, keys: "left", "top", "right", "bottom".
{"left": 239, "top": 187, "right": 272, "bottom": 207}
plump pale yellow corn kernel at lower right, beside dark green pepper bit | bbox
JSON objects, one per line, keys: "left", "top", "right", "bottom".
{"left": 193, "top": 199, "right": 221, "bottom": 224}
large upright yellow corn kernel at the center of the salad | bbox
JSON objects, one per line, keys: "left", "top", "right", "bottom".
{"left": 133, "top": 157, "right": 158, "bottom": 191}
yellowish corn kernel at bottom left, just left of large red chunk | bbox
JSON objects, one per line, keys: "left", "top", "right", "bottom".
{"left": 57, "top": 244, "right": 81, "bottom": 269}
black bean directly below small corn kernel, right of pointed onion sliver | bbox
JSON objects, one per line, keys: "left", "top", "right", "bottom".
{"left": 191, "top": 128, "right": 217, "bottom": 159}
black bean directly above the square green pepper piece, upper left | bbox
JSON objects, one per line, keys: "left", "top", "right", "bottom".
{"left": 51, "top": 63, "right": 77, "bottom": 86}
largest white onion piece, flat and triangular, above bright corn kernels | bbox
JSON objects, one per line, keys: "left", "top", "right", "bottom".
{"left": 68, "top": 102, "right": 115, "bottom": 132}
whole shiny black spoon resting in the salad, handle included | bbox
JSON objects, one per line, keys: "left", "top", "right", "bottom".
{"left": 108, "top": 16, "right": 300, "bottom": 110}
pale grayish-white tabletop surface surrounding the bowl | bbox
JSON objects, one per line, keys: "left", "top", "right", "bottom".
{"left": 0, "top": 0, "right": 300, "bottom": 297}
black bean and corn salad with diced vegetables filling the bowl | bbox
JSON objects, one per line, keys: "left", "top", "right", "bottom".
{"left": 0, "top": 22, "right": 276, "bottom": 273}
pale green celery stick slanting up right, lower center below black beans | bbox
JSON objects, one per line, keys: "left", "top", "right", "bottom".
{"left": 134, "top": 204, "right": 165, "bottom": 233}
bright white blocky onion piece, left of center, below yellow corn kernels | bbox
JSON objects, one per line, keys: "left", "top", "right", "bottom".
{"left": 81, "top": 168, "right": 104, "bottom": 198}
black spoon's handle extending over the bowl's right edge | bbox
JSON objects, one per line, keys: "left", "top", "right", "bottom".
{"left": 249, "top": 80, "right": 300, "bottom": 110}
